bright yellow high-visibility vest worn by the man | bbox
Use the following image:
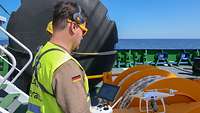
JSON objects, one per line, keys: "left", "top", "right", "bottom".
{"left": 27, "top": 42, "right": 89, "bottom": 113}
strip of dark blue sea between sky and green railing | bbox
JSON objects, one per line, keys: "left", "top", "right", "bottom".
{"left": 116, "top": 39, "right": 200, "bottom": 49}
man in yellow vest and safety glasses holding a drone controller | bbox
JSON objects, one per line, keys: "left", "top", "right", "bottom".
{"left": 27, "top": 2, "right": 90, "bottom": 113}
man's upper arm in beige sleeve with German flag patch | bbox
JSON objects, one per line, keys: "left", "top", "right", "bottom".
{"left": 52, "top": 60, "right": 90, "bottom": 113}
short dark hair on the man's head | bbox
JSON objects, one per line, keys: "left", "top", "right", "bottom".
{"left": 52, "top": 1, "right": 87, "bottom": 30}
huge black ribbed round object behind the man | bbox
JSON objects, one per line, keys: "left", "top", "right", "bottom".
{"left": 7, "top": 0, "right": 118, "bottom": 92}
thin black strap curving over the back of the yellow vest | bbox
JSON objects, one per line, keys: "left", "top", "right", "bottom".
{"left": 33, "top": 48, "right": 64, "bottom": 97}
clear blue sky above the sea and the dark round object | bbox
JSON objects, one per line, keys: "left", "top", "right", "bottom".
{"left": 0, "top": 0, "right": 200, "bottom": 39}
